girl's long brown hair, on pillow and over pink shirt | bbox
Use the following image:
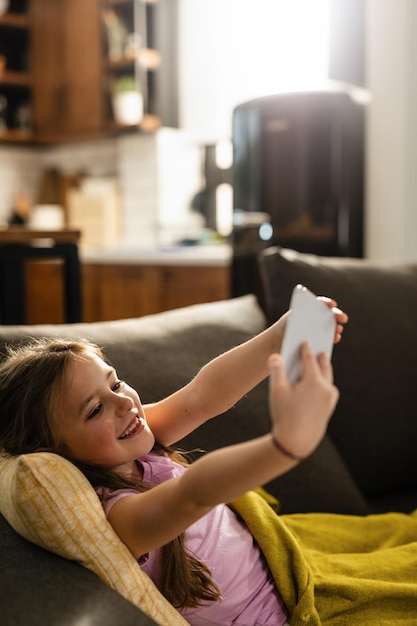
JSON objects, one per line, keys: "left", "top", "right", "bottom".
{"left": 0, "top": 339, "right": 221, "bottom": 608}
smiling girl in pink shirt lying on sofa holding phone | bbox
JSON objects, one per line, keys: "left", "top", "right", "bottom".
{"left": 0, "top": 299, "right": 347, "bottom": 626}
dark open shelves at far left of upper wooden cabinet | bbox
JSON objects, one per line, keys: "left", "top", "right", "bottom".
{"left": 0, "top": 0, "right": 33, "bottom": 142}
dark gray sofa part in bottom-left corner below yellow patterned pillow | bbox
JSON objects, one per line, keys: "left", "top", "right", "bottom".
{"left": 0, "top": 508, "right": 156, "bottom": 626}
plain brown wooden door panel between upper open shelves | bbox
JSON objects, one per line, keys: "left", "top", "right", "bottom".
{"left": 31, "top": 0, "right": 103, "bottom": 141}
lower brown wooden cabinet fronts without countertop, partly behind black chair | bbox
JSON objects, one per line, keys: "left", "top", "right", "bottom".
{"left": 26, "top": 259, "right": 230, "bottom": 324}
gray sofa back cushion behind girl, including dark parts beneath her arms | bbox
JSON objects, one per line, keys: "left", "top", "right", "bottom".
{"left": 0, "top": 295, "right": 367, "bottom": 513}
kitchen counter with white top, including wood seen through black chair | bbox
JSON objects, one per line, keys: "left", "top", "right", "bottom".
{"left": 17, "top": 238, "right": 232, "bottom": 324}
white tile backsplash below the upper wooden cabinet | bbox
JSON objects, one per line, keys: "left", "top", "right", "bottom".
{"left": 0, "top": 128, "right": 203, "bottom": 247}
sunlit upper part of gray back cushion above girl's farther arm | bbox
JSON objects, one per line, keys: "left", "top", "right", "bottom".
{"left": 0, "top": 296, "right": 265, "bottom": 403}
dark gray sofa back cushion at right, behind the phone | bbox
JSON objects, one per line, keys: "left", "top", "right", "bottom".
{"left": 259, "top": 247, "right": 417, "bottom": 497}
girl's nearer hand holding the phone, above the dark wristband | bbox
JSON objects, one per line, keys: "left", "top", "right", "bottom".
{"left": 268, "top": 343, "right": 339, "bottom": 459}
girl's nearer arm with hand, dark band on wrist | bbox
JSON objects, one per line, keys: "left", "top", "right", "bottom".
{"left": 108, "top": 344, "right": 338, "bottom": 558}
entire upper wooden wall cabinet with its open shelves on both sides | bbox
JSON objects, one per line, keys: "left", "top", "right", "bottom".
{"left": 0, "top": 0, "right": 178, "bottom": 143}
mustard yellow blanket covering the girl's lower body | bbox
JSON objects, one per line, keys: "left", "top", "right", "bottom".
{"left": 231, "top": 492, "right": 417, "bottom": 626}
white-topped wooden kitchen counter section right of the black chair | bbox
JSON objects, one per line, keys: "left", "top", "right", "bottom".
{"left": 80, "top": 244, "right": 232, "bottom": 322}
